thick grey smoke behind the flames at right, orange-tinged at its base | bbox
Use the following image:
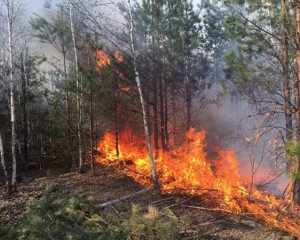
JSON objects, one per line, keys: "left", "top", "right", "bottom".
{"left": 194, "top": 84, "right": 288, "bottom": 195}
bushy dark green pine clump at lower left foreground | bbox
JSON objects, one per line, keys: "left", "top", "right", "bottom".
{"left": 19, "top": 190, "right": 106, "bottom": 239}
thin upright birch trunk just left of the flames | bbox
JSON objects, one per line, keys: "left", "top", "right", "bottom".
{"left": 69, "top": 1, "right": 83, "bottom": 173}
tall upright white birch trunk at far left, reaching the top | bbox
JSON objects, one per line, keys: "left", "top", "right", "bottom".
{"left": 6, "top": 1, "right": 17, "bottom": 192}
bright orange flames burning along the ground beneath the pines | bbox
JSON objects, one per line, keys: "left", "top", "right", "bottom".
{"left": 97, "top": 129, "right": 300, "bottom": 236}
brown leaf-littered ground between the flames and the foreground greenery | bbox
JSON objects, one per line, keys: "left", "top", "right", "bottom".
{"left": 0, "top": 166, "right": 295, "bottom": 240}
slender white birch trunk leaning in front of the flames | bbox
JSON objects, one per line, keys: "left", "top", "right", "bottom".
{"left": 128, "top": 0, "right": 160, "bottom": 193}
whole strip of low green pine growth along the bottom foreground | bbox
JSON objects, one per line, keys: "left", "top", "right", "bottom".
{"left": 0, "top": 189, "right": 179, "bottom": 240}
